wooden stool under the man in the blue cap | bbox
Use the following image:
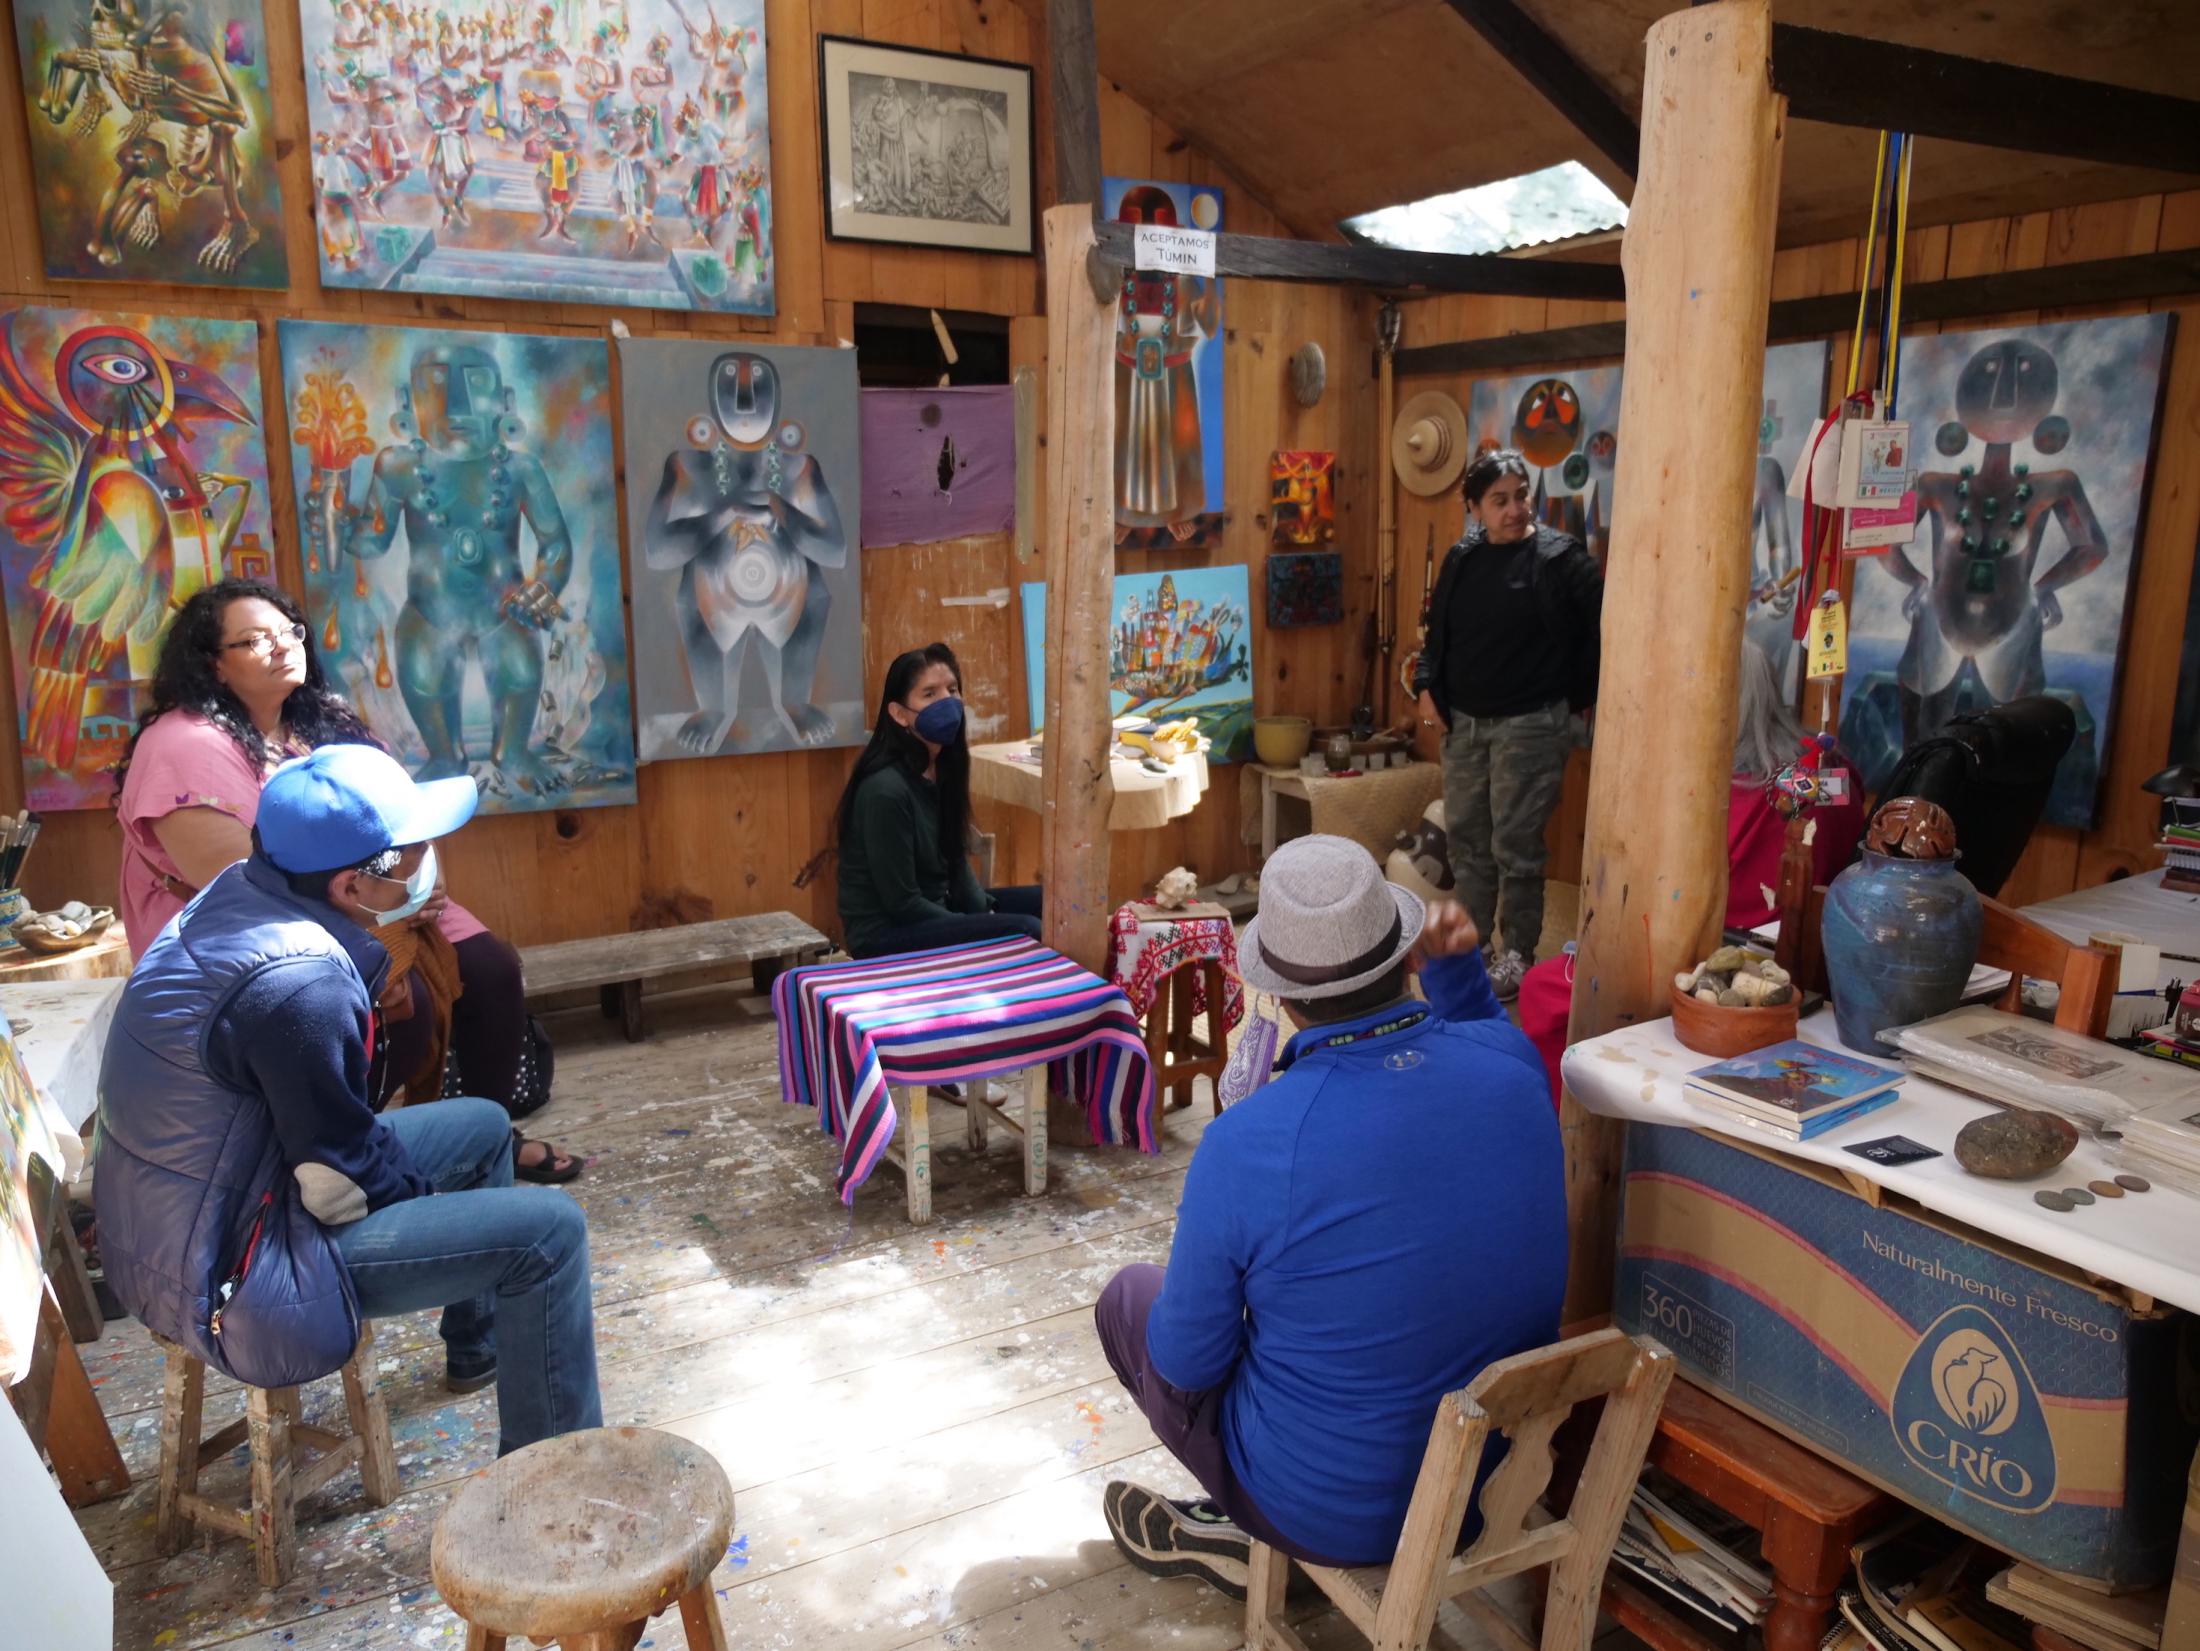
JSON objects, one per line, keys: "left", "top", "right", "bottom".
{"left": 154, "top": 1325, "right": 398, "bottom": 1587}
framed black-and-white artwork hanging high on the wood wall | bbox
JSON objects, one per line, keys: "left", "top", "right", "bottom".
{"left": 818, "top": 35, "right": 1036, "bottom": 253}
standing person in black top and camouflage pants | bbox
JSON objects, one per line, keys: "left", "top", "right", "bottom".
{"left": 1412, "top": 447, "right": 1604, "bottom": 999}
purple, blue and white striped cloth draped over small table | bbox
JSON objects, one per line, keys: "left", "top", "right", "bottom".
{"left": 772, "top": 940, "right": 1162, "bottom": 1204}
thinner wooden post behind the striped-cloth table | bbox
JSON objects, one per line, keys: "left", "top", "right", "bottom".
{"left": 1038, "top": 203, "right": 1126, "bottom": 973}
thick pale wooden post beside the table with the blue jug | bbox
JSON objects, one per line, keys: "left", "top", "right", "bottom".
{"left": 1562, "top": 0, "right": 1786, "bottom": 1323}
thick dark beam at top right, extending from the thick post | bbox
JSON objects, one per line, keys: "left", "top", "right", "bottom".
{"left": 1768, "top": 25, "right": 2200, "bottom": 172}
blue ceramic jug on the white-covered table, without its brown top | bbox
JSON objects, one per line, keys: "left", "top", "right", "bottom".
{"left": 1819, "top": 850, "right": 1980, "bottom": 1054}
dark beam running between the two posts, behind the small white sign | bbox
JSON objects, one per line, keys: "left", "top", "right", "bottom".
{"left": 1093, "top": 222, "right": 1626, "bottom": 302}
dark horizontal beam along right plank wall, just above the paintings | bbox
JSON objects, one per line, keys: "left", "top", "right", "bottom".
{"left": 1393, "top": 249, "right": 2200, "bottom": 376}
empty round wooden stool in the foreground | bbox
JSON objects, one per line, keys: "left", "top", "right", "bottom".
{"left": 427, "top": 1426, "right": 733, "bottom": 1651}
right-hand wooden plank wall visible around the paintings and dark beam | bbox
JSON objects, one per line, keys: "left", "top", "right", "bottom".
{"left": 1399, "top": 189, "right": 2200, "bottom": 920}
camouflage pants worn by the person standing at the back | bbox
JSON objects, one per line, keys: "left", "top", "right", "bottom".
{"left": 1443, "top": 700, "right": 1577, "bottom": 962}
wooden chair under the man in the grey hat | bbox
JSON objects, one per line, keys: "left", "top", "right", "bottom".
{"left": 1245, "top": 1330, "right": 1674, "bottom": 1651}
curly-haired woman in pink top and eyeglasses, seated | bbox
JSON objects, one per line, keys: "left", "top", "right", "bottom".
{"left": 114, "top": 579, "right": 581, "bottom": 1182}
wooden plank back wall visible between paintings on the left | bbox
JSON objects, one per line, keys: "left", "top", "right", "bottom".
{"left": 0, "top": 0, "right": 1375, "bottom": 944}
